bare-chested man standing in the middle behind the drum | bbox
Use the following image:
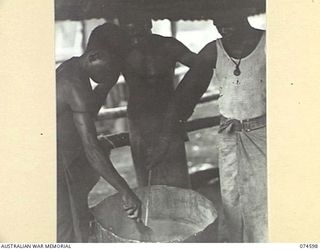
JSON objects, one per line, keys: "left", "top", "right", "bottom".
{"left": 120, "top": 13, "right": 208, "bottom": 188}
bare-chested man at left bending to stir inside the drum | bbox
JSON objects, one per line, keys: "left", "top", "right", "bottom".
{"left": 56, "top": 25, "right": 141, "bottom": 242}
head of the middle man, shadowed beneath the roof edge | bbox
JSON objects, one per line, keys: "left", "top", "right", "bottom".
{"left": 119, "top": 11, "right": 152, "bottom": 43}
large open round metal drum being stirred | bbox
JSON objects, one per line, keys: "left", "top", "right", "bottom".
{"left": 92, "top": 185, "right": 217, "bottom": 242}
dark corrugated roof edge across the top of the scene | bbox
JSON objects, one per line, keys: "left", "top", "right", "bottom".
{"left": 55, "top": 0, "right": 265, "bottom": 21}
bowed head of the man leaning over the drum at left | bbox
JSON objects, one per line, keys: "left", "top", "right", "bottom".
{"left": 83, "top": 23, "right": 123, "bottom": 83}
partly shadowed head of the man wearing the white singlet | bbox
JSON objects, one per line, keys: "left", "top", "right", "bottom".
{"left": 213, "top": 11, "right": 251, "bottom": 39}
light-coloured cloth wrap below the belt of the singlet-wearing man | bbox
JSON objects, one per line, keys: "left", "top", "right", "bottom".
{"left": 219, "top": 127, "right": 268, "bottom": 242}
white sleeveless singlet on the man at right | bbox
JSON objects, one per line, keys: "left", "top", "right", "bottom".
{"left": 214, "top": 33, "right": 266, "bottom": 120}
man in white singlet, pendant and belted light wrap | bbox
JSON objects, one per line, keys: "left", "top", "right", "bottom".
{"left": 200, "top": 12, "right": 268, "bottom": 242}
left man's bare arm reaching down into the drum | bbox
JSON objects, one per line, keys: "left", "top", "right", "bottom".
{"left": 68, "top": 83, "right": 141, "bottom": 218}
